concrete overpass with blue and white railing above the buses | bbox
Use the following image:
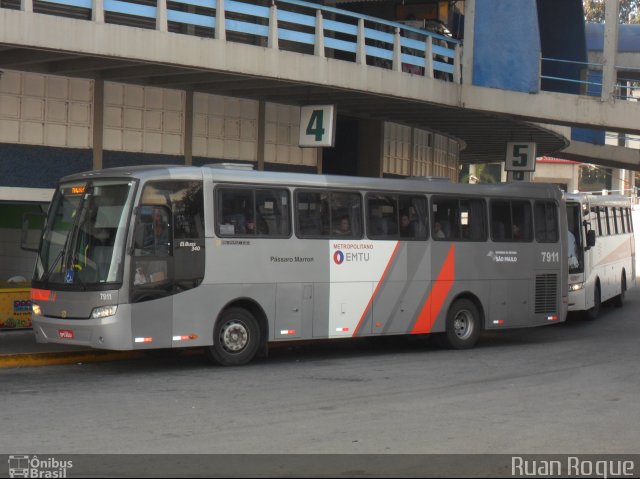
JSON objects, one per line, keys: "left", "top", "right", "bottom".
{"left": 0, "top": 0, "right": 640, "bottom": 169}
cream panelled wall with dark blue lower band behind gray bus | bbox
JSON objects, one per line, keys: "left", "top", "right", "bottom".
{"left": 0, "top": 70, "right": 317, "bottom": 188}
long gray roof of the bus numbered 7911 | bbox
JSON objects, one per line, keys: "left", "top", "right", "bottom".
{"left": 60, "top": 165, "right": 562, "bottom": 200}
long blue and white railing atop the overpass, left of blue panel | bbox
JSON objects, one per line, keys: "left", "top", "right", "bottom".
{"left": 5, "top": 0, "right": 461, "bottom": 83}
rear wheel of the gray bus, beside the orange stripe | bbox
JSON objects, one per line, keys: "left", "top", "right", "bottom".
{"left": 441, "top": 298, "right": 482, "bottom": 349}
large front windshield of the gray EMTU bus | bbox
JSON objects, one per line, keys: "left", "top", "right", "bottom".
{"left": 34, "top": 180, "right": 135, "bottom": 290}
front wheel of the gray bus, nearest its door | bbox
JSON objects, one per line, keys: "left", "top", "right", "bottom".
{"left": 207, "top": 308, "right": 260, "bottom": 366}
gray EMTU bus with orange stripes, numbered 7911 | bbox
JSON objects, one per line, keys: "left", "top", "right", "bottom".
{"left": 26, "top": 165, "right": 567, "bottom": 365}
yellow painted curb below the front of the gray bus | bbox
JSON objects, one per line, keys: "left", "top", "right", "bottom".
{"left": 0, "top": 351, "right": 144, "bottom": 369}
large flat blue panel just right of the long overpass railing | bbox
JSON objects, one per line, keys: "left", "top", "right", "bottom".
{"left": 473, "top": 0, "right": 541, "bottom": 93}
